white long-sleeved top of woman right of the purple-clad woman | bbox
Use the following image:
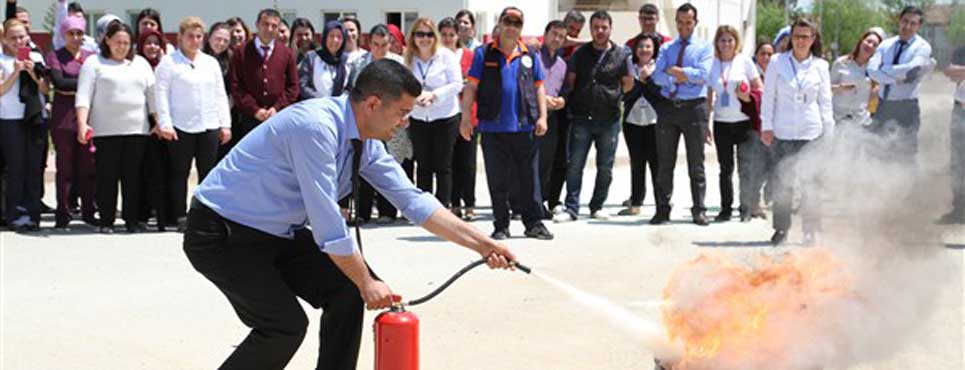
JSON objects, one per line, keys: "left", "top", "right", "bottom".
{"left": 74, "top": 55, "right": 156, "bottom": 137}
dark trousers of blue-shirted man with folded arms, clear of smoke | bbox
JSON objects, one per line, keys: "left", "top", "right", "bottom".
{"left": 657, "top": 99, "right": 708, "bottom": 215}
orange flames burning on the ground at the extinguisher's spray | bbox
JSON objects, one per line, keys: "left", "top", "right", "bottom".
{"left": 663, "top": 248, "right": 857, "bottom": 370}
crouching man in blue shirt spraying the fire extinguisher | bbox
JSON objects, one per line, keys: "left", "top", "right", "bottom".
{"left": 184, "top": 60, "right": 515, "bottom": 370}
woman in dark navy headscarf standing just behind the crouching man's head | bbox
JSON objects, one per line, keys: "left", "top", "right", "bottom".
{"left": 298, "top": 21, "right": 349, "bottom": 99}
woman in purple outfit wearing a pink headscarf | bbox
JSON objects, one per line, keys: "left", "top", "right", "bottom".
{"left": 47, "top": 16, "right": 96, "bottom": 229}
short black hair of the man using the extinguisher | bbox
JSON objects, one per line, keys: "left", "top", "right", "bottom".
{"left": 351, "top": 59, "right": 422, "bottom": 103}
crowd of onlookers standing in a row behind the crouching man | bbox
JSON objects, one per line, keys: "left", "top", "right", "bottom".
{"left": 0, "top": 0, "right": 965, "bottom": 244}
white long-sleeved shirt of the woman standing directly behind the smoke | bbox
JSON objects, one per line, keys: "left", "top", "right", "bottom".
{"left": 761, "top": 52, "right": 834, "bottom": 140}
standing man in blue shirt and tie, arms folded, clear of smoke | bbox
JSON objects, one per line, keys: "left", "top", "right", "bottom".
{"left": 650, "top": 3, "right": 714, "bottom": 226}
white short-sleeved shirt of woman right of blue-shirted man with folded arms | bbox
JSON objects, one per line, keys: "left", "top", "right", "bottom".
{"left": 708, "top": 54, "right": 761, "bottom": 123}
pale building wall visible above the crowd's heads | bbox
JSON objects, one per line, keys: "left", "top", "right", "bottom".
{"left": 20, "top": 0, "right": 756, "bottom": 53}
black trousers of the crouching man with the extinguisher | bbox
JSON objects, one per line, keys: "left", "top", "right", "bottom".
{"left": 184, "top": 201, "right": 364, "bottom": 370}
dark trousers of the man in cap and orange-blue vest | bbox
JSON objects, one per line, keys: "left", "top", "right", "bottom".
{"left": 482, "top": 132, "right": 542, "bottom": 230}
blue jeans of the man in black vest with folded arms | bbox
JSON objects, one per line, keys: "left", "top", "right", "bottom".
{"left": 565, "top": 119, "right": 620, "bottom": 216}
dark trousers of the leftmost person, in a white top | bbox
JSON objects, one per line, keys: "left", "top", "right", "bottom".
{"left": 0, "top": 120, "right": 47, "bottom": 224}
